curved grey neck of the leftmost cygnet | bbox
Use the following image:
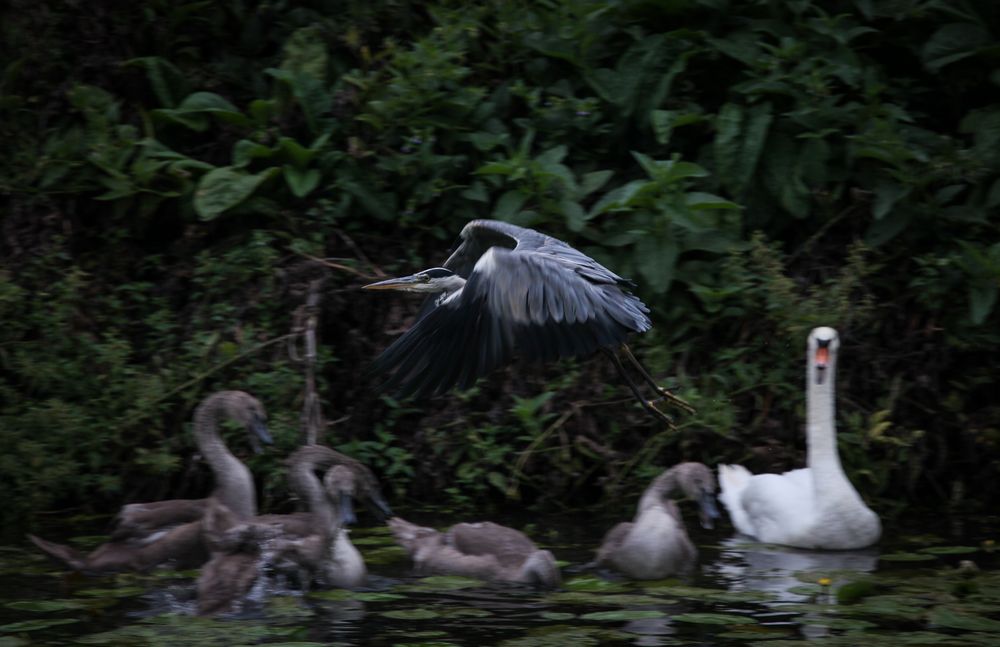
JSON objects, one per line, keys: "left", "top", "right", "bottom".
{"left": 194, "top": 396, "right": 257, "bottom": 518}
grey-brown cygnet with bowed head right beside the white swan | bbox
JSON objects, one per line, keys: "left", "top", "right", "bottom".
{"left": 595, "top": 463, "right": 719, "bottom": 580}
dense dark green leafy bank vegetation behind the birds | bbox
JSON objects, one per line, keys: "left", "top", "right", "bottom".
{"left": 0, "top": 0, "right": 1000, "bottom": 530}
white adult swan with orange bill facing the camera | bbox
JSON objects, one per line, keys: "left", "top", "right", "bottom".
{"left": 719, "top": 327, "right": 882, "bottom": 550}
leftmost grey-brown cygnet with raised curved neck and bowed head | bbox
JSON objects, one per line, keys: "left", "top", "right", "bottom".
{"left": 28, "top": 391, "right": 271, "bottom": 574}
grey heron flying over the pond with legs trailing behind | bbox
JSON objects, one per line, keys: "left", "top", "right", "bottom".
{"left": 364, "top": 220, "right": 693, "bottom": 427}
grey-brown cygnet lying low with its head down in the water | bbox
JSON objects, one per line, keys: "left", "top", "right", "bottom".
{"left": 389, "top": 517, "right": 562, "bottom": 588}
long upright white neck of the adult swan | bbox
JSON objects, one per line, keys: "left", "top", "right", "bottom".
{"left": 806, "top": 352, "right": 846, "bottom": 484}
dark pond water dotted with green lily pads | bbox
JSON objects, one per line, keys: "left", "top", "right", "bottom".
{"left": 0, "top": 514, "right": 1000, "bottom": 647}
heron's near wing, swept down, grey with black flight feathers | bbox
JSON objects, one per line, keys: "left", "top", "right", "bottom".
{"left": 372, "top": 242, "right": 651, "bottom": 396}
